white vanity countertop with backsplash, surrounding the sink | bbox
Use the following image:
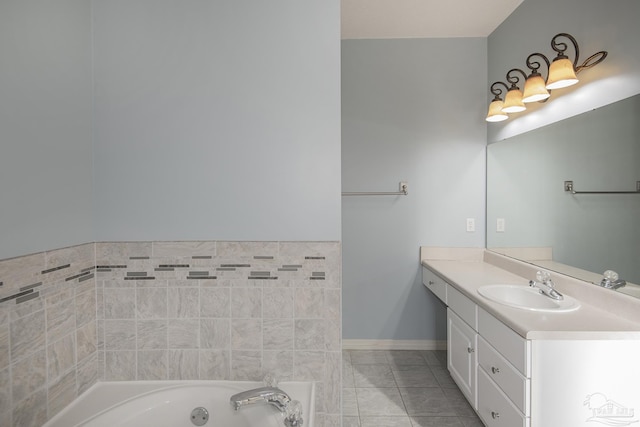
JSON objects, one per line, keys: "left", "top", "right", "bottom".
{"left": 422, "top": 249, "right": 640, "bottom": 340}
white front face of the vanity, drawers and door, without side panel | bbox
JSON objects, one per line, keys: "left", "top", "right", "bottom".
{"left": 423, "top": 268, "right": 531, "bottom": 427}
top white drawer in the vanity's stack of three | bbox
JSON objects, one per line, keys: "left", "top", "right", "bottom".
{"left": 478, "top": 309, "right": 531, "bottom": 378}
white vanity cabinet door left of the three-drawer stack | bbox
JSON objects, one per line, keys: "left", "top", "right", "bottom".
{"left": 447, "top": 309, "right": 478, "bottom": 409}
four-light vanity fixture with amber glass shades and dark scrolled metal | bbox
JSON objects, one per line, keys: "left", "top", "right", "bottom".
{"left": 486, "top": 33, "right": 607, "bottom": 122}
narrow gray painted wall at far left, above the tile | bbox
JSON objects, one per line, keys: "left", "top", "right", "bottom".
{"left": 0, "top": 0, "right": 93, "bottom": 259}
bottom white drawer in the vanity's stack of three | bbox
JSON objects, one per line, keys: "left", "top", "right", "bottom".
{"left": 478, "top": 369, "right": 529, "bottom": 427}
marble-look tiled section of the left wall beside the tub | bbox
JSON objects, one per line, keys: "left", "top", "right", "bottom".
{"left": 0, "top": 243, "right": 98, "bottom": 426}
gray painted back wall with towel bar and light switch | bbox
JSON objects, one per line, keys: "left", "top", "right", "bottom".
{"left": 342, "top": 38, "right": 487, "bottom": 340}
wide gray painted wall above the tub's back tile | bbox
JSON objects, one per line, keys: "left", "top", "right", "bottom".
{"left": 94, "top": 0, "right": 341, "bottom": 241}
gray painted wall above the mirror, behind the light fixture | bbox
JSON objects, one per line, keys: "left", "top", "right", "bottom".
{"left": 485, "top": 0, "right": 640, "bottom": 142}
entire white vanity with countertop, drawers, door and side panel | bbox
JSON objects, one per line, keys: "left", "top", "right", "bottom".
{"left": 422, "top": 253, "right": 640, "bottom": 427}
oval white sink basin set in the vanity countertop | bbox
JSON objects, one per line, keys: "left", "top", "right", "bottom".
{"left": 478, "top": 284, "right": 580, "bottom": 313}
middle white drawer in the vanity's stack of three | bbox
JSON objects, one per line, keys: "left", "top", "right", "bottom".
{"left": 478, "top": 336, "right": 530, "bottom": 416}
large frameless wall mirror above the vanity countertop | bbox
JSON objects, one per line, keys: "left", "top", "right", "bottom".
{"left": 487, "top": 95, "right": 640, "bottom": 297}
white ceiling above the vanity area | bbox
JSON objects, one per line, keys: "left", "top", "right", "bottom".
{"left": 342, "top": 0, "right": 523, "bottom": 39}
